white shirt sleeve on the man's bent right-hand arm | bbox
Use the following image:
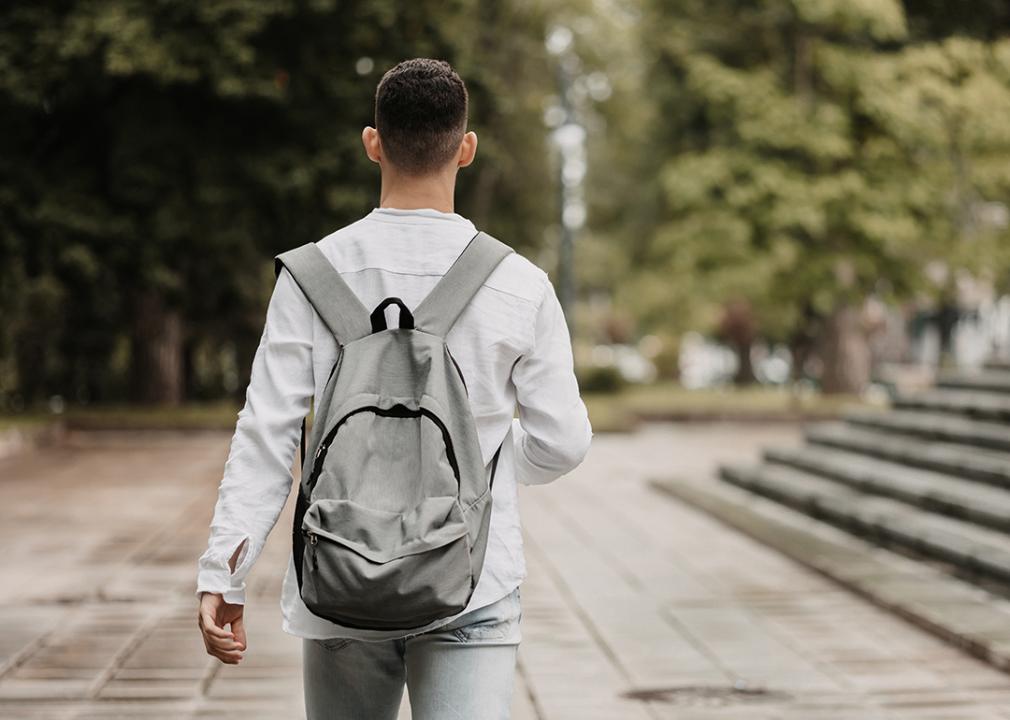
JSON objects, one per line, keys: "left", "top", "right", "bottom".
{"left": 512, "top": 276, "right": 593, "bottom": 485}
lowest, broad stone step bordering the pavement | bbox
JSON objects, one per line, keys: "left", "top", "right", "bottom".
{"left": 652, "top": 480, "right": 1010, "bottom": 672}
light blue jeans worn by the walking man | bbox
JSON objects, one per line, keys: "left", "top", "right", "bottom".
{"left": 303, "top": 588, "right": 522, "bottom": 720}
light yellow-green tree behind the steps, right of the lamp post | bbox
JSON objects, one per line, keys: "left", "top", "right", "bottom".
{"left": 634, "top": 0, "right": 1010, "bottom": 392}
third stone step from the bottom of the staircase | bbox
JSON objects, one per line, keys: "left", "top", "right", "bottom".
{"left": 765, "top": 445, "right": 1010, "bottom": 532}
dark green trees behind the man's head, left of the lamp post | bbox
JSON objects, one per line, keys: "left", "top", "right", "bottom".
{"left": 0, "top": 0, "right": 551, "bottom": 403}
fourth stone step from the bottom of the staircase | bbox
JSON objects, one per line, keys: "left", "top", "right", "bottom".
{"left": 805, "top": 422, "right": 1010, "bottom": 489}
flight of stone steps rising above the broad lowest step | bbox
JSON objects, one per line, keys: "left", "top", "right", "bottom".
{"left": 720, "top": 359, "right": 1010, "bottom": 595}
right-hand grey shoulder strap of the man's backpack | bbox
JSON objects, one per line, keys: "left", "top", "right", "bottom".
{"left": 414, "top": 232, "right": 512, "bottom": 337}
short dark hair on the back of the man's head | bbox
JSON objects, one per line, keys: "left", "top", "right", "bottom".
{"left": 376, "top": 58, "right": 469, "bottom": 176}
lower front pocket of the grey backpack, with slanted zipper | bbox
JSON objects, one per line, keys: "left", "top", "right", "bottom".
{"left": 301, "top": 497, "right": 475, "bottom": 629}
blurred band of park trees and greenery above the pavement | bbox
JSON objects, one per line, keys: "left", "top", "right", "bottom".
{"left": 0, "top": 0, "right": 1010, "bottom": 429}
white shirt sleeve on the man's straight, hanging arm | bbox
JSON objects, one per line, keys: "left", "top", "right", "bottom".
{"left": 197, "top": 269, "right": 314, "bottom": 603}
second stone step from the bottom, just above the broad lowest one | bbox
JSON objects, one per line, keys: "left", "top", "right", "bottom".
{"left": 720, "top": 465, "right": 1010, "bottom": 587}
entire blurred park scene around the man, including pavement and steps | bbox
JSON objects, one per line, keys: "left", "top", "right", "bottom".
{"left": 0, "top": 0, "right": 1010, "bottom": 720}
